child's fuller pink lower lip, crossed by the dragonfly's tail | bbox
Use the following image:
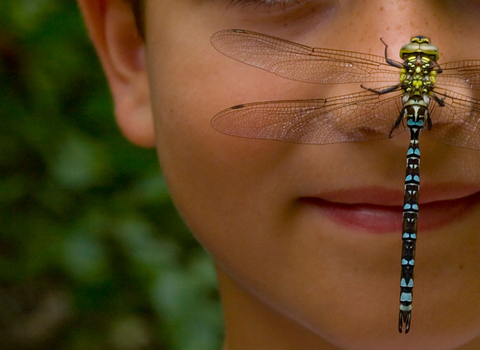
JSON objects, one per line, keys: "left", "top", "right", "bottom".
{"left": 300, "top": 192, "right": 480, "bottom": 234}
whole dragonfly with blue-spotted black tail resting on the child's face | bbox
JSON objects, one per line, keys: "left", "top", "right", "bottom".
{"left": 211, "top": 29, "right": 480, "bottom": 333}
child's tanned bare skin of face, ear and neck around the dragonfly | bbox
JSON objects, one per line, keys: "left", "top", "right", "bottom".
{"left": 79, "top": 0, "right": 480, "bottom": 350}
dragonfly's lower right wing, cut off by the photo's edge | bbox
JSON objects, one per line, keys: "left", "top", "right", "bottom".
{"left": 422, "top": 88, "right": 480, "bottom": 150}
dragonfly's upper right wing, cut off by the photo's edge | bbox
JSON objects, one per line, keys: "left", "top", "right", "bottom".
{"left": 437, "top": 60, "right": 480, "bottom": 90}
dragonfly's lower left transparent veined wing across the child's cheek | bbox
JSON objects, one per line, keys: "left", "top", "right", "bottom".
{"left": 212, "top": 91, "right": 405, "bottom": 144}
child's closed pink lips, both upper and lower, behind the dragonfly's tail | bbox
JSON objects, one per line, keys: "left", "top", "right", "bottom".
{"left": 300, "top": 185, "right": 480, "bottom": 234}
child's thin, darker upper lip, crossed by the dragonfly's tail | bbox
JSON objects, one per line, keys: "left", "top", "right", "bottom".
{"left": 306, "top": 183, "right": 480, "bottom": 206}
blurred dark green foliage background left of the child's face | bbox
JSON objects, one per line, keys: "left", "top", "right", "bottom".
{"left": 0, "top": 0, "right": 222, "bottom": 350}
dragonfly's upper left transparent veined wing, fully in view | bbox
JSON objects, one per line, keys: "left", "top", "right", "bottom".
{"left": 210, "top": 29, "right": 400, "bottom": 84}
